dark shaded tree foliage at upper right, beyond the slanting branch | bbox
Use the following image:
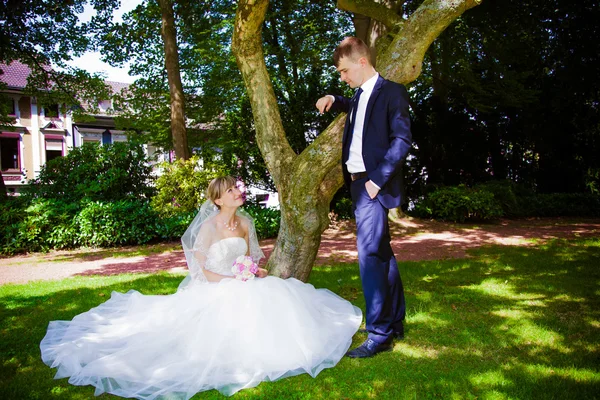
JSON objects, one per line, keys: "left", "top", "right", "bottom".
{"left": 411, "top": 0, "right": 600, "bottom": 197}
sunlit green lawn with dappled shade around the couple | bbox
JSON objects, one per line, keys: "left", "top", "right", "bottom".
{"left": 0, "top": 239, "right": 600, "bottom": 400}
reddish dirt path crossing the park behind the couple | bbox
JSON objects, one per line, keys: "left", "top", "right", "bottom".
{"left": 0, "top": 218, "right": 600, "bottom": 285}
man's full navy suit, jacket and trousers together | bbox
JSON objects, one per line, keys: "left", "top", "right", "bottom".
{"left": 331, "top": 76, "right": 412, "bottom": 343}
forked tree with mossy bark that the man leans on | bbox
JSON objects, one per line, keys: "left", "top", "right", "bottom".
{"left": 232, "top": 0, "right": 479, "bottom": 280}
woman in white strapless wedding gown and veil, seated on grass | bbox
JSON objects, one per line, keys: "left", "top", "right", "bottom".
{"left": 40, "top": 177, "right": 362, "bottom": 399}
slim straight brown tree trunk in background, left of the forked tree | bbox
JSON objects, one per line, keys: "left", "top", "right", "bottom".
{"left": 158, "top": 0, "right": 190, "bottom": 160}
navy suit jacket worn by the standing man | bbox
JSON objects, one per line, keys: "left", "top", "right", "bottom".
{"left": 331, "top": 76, "right": 412, "bottom": 209}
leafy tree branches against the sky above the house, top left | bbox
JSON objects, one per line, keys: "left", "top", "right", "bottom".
{"left": 0, "top": 0, "right": 119, "bottom": 116}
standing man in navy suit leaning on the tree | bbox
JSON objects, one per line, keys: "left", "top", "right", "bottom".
{"left": 316, "top": 37, "right": 412, "bottom": 358}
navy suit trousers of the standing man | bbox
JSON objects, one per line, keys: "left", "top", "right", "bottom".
{"left": 350, "top": 178, "right": 406, "bottom": 343}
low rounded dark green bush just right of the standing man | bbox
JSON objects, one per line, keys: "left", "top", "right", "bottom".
{"left": 412, "top": 185, "right": 503, "bottom": 222}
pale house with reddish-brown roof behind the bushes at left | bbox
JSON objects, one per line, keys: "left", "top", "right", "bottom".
{"left": 0, "top": 61, "right": 159, "bottom": 193}
